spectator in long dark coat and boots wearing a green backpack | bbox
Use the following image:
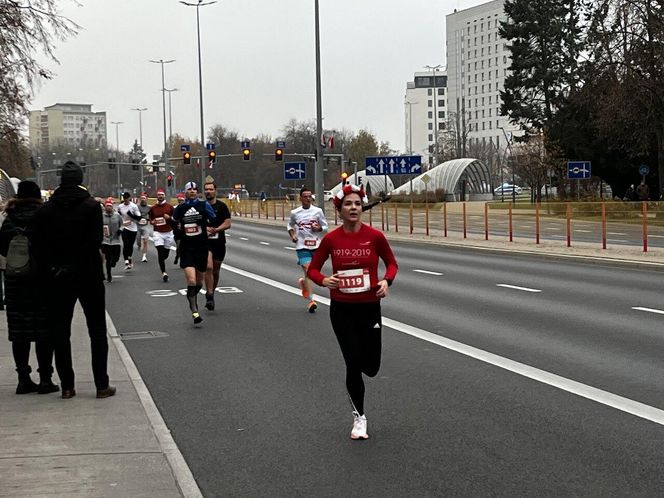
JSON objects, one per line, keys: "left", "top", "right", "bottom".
{"left": 0, "top": 181, "right": 59, "bottom": 394}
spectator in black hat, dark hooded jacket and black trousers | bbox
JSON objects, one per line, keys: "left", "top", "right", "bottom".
{"left": 34, "top": 161, "right": 115, "bottom": 399}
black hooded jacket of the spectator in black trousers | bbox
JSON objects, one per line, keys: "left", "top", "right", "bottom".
{"left": 34, "top": 185, "right": 103, "bottom": 283}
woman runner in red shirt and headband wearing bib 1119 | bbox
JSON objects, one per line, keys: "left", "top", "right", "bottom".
{"left": 307, "top": 185, "right": 398, "bottom": 440}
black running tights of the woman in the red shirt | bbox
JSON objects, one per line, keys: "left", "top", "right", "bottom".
{"left": 330, "top": 301, "right": 382, "bottom": 415}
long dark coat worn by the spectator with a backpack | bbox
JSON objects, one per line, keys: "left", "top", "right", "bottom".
{"left": 0, "top": 199, "right": 48, "bottom": 341}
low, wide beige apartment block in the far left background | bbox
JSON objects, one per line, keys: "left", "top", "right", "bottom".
{"left": 29, "top": 104, "right": 106, "bottom": 148}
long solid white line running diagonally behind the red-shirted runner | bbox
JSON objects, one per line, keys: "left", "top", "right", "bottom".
{"left": 223, "top": 263, "right": 664, "bottom": 425}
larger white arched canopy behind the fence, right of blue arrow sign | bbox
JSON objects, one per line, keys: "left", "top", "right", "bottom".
{"left": 392, "top": 158, "right": 493, "bottom": 201}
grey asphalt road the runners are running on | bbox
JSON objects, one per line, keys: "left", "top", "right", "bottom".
{"left": 107, "top": 221, "right": 664, "bottom": 496}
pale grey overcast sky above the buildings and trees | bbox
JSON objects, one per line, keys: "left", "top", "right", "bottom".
{"left": 31, "top": 0, "right": 484, "bottom": 158}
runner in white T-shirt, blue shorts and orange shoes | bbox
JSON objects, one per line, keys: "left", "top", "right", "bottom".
{"left": 287, "top": 187, "right": 327, "bottom": 313}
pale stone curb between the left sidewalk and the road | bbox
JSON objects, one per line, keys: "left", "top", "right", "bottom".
{"left": 106, "top": 311, "right": 203, "bottom": 498}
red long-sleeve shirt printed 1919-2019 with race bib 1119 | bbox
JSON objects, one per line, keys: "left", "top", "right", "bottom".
{"left": 307, "top": 224, "right": 398, "bottom": 303}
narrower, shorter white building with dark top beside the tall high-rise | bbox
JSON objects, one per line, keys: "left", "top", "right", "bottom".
{"left": 404, "top": 70, "right": 447, "bottom": 166}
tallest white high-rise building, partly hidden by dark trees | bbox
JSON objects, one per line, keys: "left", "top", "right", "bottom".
{"left": 446, "top": 0, "right": 521, "bottom": 152}
